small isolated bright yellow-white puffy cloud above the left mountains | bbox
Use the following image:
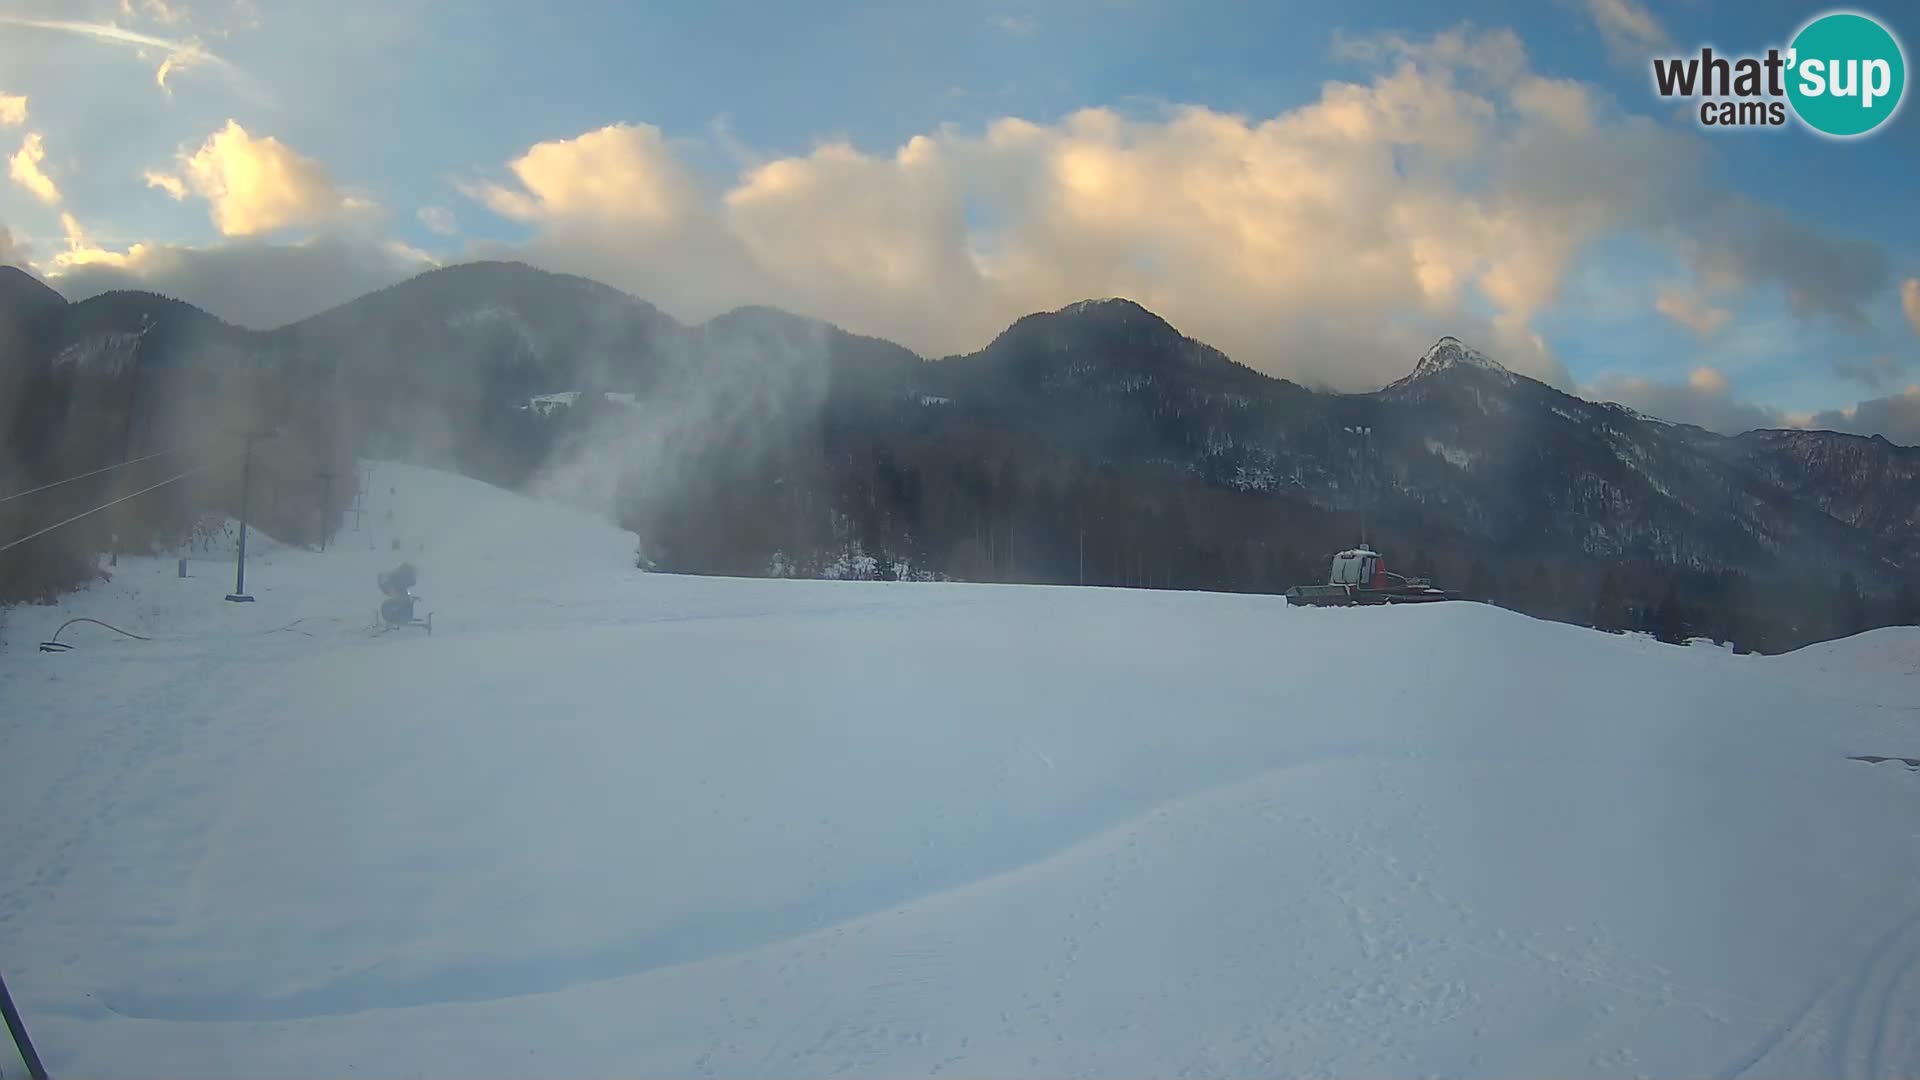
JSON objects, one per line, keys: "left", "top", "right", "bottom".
{"left": 168, "top": 119, "right": 372, "bottom": 236}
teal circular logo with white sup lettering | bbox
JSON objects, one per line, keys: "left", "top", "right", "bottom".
{"left": 1788, "top": 12, "right": 1907, "bottom": 138}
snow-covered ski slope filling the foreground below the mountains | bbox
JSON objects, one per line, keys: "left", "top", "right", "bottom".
{"left": 0, "top": 457, "right": 1920, "bottom": 1078}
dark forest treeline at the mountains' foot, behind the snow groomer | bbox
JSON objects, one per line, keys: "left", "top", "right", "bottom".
{"left": 630, "top": 424, "right": 1920, "bottom": 653}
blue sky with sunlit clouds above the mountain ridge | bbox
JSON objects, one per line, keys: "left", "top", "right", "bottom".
{"left": 0, "top": 0, "right": 1920, "bottom": 442}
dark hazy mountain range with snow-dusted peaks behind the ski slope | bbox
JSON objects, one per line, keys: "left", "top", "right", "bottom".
{"left": 0, "top": 263, "right": 1920, "bottom": 645}
